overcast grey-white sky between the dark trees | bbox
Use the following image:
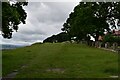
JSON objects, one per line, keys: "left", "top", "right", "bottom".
{"left": 0, "top": 2, "right": 79, "bottom": 44}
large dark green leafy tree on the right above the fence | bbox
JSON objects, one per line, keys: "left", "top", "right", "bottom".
{"left": 62, "top": 2, "right": 120, "bottom": 41}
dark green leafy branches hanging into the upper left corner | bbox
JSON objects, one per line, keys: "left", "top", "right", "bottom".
{"left": 1, "top": 1, "right": 28, "bottom": 39}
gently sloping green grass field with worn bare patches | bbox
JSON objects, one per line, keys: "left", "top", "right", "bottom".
{"left": 2, "top": 43, "right": 118, "bottom": 78}
